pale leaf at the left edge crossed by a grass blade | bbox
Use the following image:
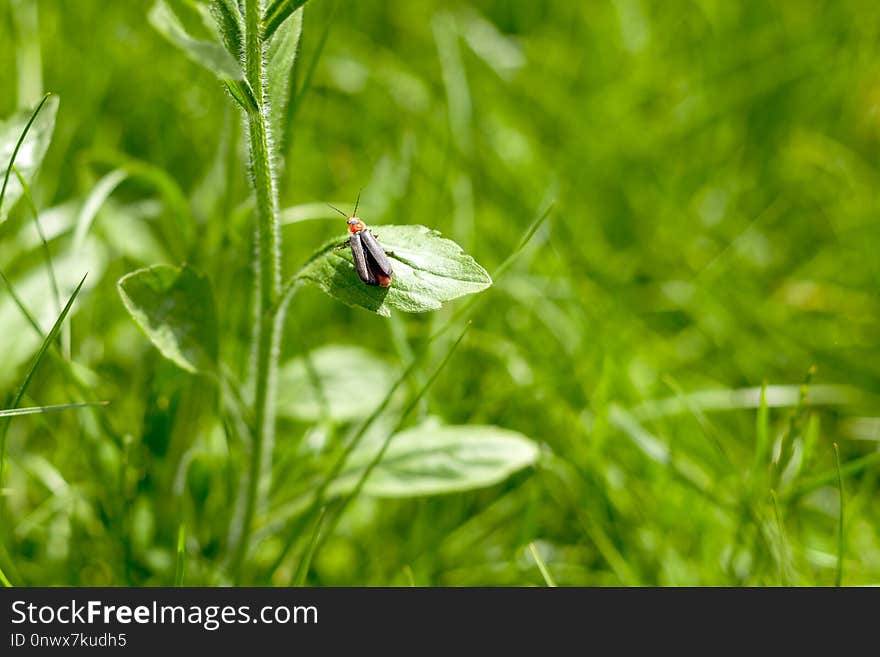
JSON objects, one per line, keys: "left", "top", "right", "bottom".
{"left": 0, "top": 95, "right": 58, "bottom": 223}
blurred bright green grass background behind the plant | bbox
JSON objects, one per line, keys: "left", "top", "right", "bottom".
{"left": 0, "top": 0, "right": 880, "bottom": 586}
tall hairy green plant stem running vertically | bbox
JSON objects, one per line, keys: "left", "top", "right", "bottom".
{"left": 232, "top": 0, "right": 284, "bottom": 583}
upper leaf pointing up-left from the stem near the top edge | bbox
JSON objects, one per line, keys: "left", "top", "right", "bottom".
{"left": 149, "top": 0, "right": 257, "bottom": 112}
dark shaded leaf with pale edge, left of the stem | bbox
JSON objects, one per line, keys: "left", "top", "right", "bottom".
{"left": 116, "top": 265, "right": 217, "bottom": 372}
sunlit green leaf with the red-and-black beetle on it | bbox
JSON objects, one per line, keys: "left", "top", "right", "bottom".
{"left": 297, "top": 226, "right": 492, "bottom": 317}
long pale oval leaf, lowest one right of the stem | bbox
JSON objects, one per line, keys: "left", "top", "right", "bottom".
{"left": 331, "top": 422, "right": 538, "bottom": 497}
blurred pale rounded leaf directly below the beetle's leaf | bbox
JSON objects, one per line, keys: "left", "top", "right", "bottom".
{"left": 278, "top": 345, "right": 396, "bottom": 422}
